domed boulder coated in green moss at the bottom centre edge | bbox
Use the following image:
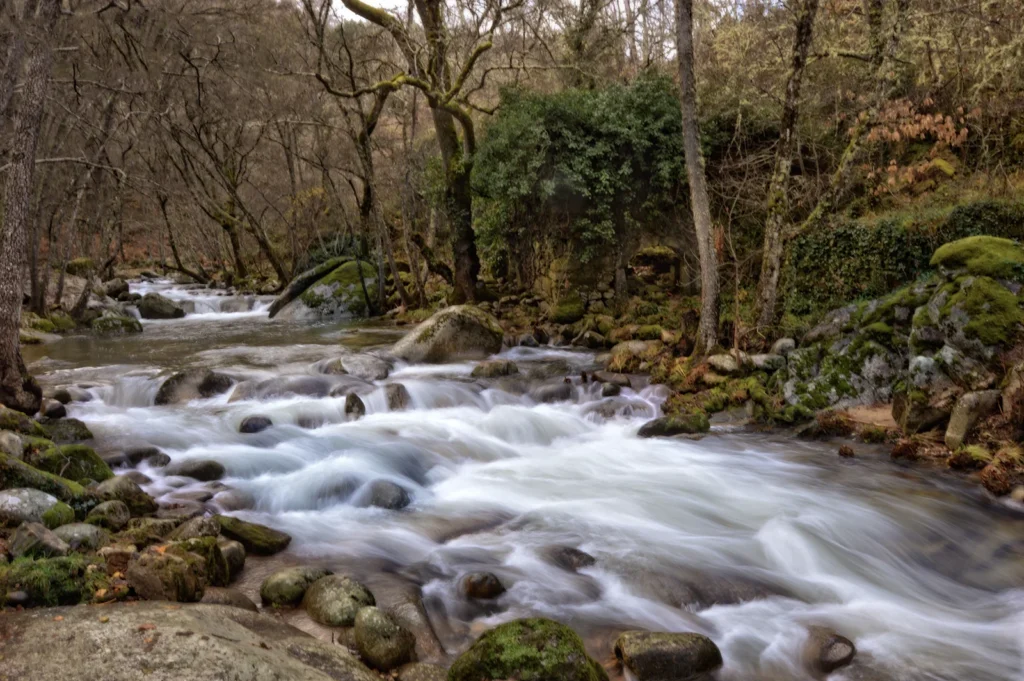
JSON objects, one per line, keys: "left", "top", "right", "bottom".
{"left": 447, "top": 618, "right": 608, "bottom": 681}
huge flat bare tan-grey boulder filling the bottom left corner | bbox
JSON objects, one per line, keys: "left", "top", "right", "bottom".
{"left": 0, "top": 602, "right": 380, "bottom": 681}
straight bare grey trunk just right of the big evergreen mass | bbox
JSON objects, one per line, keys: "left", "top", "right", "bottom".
{"left": 676, "top": 0, "right": 719, "bottom": 355}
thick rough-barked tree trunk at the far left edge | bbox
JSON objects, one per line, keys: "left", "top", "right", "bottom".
{"left": 0, "top": 0, "right": 59, "bottom": 414}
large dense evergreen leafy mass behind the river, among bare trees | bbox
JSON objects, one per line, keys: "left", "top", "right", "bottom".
{"left": 473, "top": 76, "right": 684, "bottom": 278}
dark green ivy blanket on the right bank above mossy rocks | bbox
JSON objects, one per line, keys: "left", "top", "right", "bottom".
{"left": 784, "top": 201, "right": 1024, "bottom": 316}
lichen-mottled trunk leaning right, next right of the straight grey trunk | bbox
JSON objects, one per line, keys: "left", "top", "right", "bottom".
{"left": 756, "top": 0, "right": 818, "bottom": 334}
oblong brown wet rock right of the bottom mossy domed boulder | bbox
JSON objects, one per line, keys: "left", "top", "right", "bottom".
{"left": 615, "top": 631, "right": 722, "bottom": 681}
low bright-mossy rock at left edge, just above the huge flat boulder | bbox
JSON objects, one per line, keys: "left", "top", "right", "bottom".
{"left": 0, "top": 553, "right": 110, "bottom": 605}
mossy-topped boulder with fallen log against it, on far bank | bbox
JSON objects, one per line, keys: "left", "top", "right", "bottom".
{"left": 275, "top": 260, "right": 377, "bottom": 320}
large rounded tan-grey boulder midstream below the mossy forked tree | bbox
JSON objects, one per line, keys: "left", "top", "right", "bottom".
{"left": 391, "top": 305, "right": 505, "bottom": 363}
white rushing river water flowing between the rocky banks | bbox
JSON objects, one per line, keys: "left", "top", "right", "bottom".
{"left": 19, "top": 283, "right": 1024, "bottom": 681}
